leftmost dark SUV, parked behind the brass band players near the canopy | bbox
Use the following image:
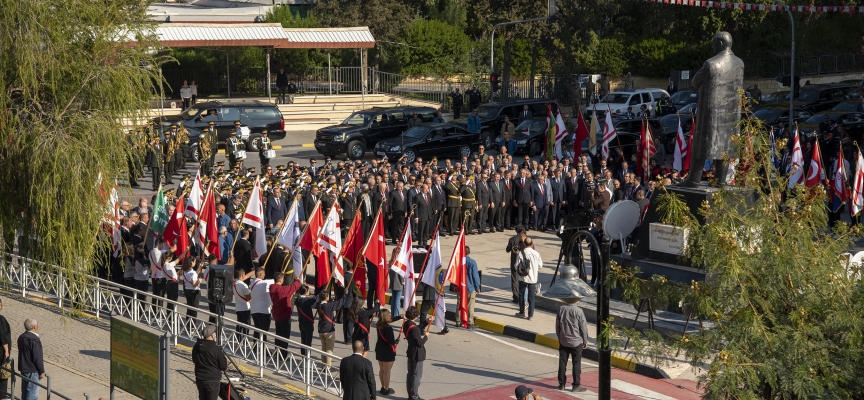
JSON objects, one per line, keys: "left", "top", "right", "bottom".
{"left": 153, "top": 100, "right": 285, "bottom": 161}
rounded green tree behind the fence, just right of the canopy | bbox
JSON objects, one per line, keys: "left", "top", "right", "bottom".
{"left": 399, "top": 19, "right": 471, "bottom": 75}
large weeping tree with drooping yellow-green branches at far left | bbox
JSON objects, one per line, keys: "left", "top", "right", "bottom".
{"left": 0, "top": 0, "right": 158, "bottom": 279}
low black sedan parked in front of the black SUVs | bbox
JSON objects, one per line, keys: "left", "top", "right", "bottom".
{"left": 374, "top": 122, "right": 481, "bottom": 163}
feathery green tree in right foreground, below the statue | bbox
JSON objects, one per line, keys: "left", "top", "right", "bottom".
{"left": 611, "top": 99, "right": 864, "bottom": 399}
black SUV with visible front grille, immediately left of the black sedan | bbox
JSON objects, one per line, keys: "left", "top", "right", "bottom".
{"left": 315, "top": 107, "right": 436, "bottom": 160}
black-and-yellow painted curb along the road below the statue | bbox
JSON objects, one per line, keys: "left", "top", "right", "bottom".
{"left": 386, "top": 293, "right": 669, "bottom": 379}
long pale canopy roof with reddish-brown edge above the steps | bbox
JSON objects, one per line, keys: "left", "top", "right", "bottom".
{"left": 156, "top": 23, "right": 375, "bottom": 49}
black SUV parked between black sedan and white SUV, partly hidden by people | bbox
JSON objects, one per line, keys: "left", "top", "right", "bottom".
{"left": 466, "top": 99, "right": 558, "bottom": 149}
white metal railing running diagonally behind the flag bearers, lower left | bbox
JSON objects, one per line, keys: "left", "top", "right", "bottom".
{"left": 0, "top": 253, "right": 342, "bottom": 395}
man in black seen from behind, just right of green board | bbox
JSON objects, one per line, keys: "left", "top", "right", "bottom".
{"left": 192, "top": 325, "right": 228, "bottom": 400}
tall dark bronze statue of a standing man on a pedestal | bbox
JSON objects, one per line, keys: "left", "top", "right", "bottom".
{"left": 688, "top": 32, "right": 744, "bottom": 186}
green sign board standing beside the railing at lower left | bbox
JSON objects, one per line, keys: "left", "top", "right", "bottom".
{"left": 111, "top": 315, "right": 162, "bottom": 400}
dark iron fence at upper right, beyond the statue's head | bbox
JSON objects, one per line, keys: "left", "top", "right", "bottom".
{"left": 744, "top": 54, "right": 864, "bottom": 79}
